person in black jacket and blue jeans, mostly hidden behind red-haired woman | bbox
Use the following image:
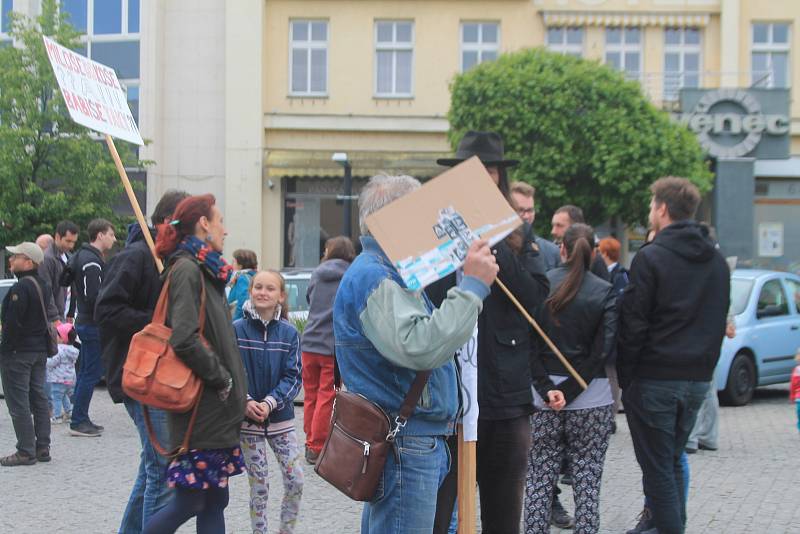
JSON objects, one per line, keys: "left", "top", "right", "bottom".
{"left": 95, "top": 190, "right": 189, "bottom": 533}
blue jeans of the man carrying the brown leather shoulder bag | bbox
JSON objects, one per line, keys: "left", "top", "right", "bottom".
{"left": 361, "top": 436, "right": 450, "bottom": 534}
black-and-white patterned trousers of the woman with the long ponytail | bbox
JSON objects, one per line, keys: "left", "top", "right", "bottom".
{"left": 525, "top": 406, "right": 614, "bottom": 534}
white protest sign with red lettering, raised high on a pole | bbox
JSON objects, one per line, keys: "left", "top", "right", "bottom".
{"left": 44, "top": 37, "right": 144, "bottom": 145}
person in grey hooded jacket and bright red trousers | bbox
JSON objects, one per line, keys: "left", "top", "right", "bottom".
{"left": 301, "top": 236, "right": 356, "bottom": 464}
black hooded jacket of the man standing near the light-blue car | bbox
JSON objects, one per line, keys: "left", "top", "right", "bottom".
{"left": 617, "top": 221, "right": 730, "bottom": 388}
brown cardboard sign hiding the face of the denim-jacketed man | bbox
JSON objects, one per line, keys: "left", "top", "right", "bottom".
{"left": 366, "top": 157, "right": 522, "bottom": 290}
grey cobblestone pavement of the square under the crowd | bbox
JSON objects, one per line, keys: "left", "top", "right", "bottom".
{"left": 0, "top": 386, "right": 800, "bottom": 534}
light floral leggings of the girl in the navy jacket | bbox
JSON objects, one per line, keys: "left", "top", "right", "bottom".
{"left": 241, "top": 430, "right": 303, "bottom": 534}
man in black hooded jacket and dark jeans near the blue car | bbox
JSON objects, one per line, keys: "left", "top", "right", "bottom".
{"left": 617, "top": 177, "right": 730, "bottom": 534}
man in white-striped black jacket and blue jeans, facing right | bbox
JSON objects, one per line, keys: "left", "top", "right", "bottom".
{"left": 67, "top": 219, "right": 117, "bottom": 437}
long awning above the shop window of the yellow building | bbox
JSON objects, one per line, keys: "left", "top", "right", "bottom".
{"left": 264, "top": 150, "right": 451, "bottom": 179}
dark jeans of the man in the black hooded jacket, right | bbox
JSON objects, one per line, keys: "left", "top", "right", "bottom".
{"left": 622, "top": 378, "right": 709, "bottom": 534}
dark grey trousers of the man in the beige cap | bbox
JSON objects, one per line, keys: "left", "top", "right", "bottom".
{"left": 0, "top": 352, "right": 50, "bottom": 456}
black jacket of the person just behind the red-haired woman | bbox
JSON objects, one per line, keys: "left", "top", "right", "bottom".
{"left": 94, "top": 224, "right": 161, "bottom": 403}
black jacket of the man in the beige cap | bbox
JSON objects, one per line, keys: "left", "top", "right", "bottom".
{"left": 0, "top": 270, "right": 52, "bottom": 355}
